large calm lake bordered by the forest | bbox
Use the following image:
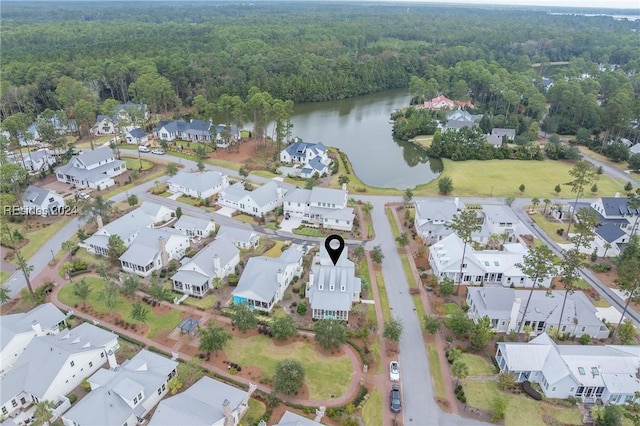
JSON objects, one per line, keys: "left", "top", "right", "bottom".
{"left": 291, "top": 89, "right": 442, "bottom": 189}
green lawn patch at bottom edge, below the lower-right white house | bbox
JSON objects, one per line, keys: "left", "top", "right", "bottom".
{"left": 463, "top": 380, "right": 582, "bottom": 426}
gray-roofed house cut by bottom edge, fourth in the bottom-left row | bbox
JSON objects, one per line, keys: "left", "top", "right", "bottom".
{"left": 149, "top": 376, "right": 256, "bottom": 426}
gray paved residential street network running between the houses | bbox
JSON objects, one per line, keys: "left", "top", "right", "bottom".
{"left": 7, "top": 150, "right": 640, "bottom": 426}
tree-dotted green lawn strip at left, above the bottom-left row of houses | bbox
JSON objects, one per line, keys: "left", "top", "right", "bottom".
{"left": 58, "top": 277, "right": 182, "bottom": 339}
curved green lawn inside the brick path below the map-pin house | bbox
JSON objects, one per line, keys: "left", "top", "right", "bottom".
{"left": 224, "top": 336, "right": 353, "bottom": 399}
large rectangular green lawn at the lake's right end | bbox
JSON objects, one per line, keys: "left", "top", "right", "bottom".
{"left": 413, "top": 159, "right": 624, "bottom": 199}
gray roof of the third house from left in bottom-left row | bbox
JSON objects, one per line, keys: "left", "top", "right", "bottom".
{"left": 63, "top": 349, "right": 178, "bottom": 425}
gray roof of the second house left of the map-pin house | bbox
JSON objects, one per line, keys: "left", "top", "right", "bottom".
{"left": 171, "top": 236, "right": 240, "bottom": 283}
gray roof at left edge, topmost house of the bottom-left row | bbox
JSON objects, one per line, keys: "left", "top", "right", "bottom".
{"left": 0, "top": 303, "right": 66, "bottom": 350}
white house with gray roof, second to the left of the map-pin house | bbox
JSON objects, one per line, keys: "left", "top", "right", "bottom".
{"left": 171, "top": 236, "right": 240, "bottom": 297}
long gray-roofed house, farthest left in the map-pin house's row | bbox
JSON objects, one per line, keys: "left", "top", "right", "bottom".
{"left": 80, "top": 201, "right": 175, "bottom": 256}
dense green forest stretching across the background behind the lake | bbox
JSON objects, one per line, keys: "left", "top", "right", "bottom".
{"left": 0, "top": 2, "right": 640, "bottom": 153}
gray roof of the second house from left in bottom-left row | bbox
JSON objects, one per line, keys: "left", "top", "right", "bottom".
{"left": 0, "top": 323, "right": 118, "bottom": 405}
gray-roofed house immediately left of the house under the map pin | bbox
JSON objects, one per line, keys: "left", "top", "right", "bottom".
{"left": 231, "top": 245, "right": 304, "bottom": 312}
